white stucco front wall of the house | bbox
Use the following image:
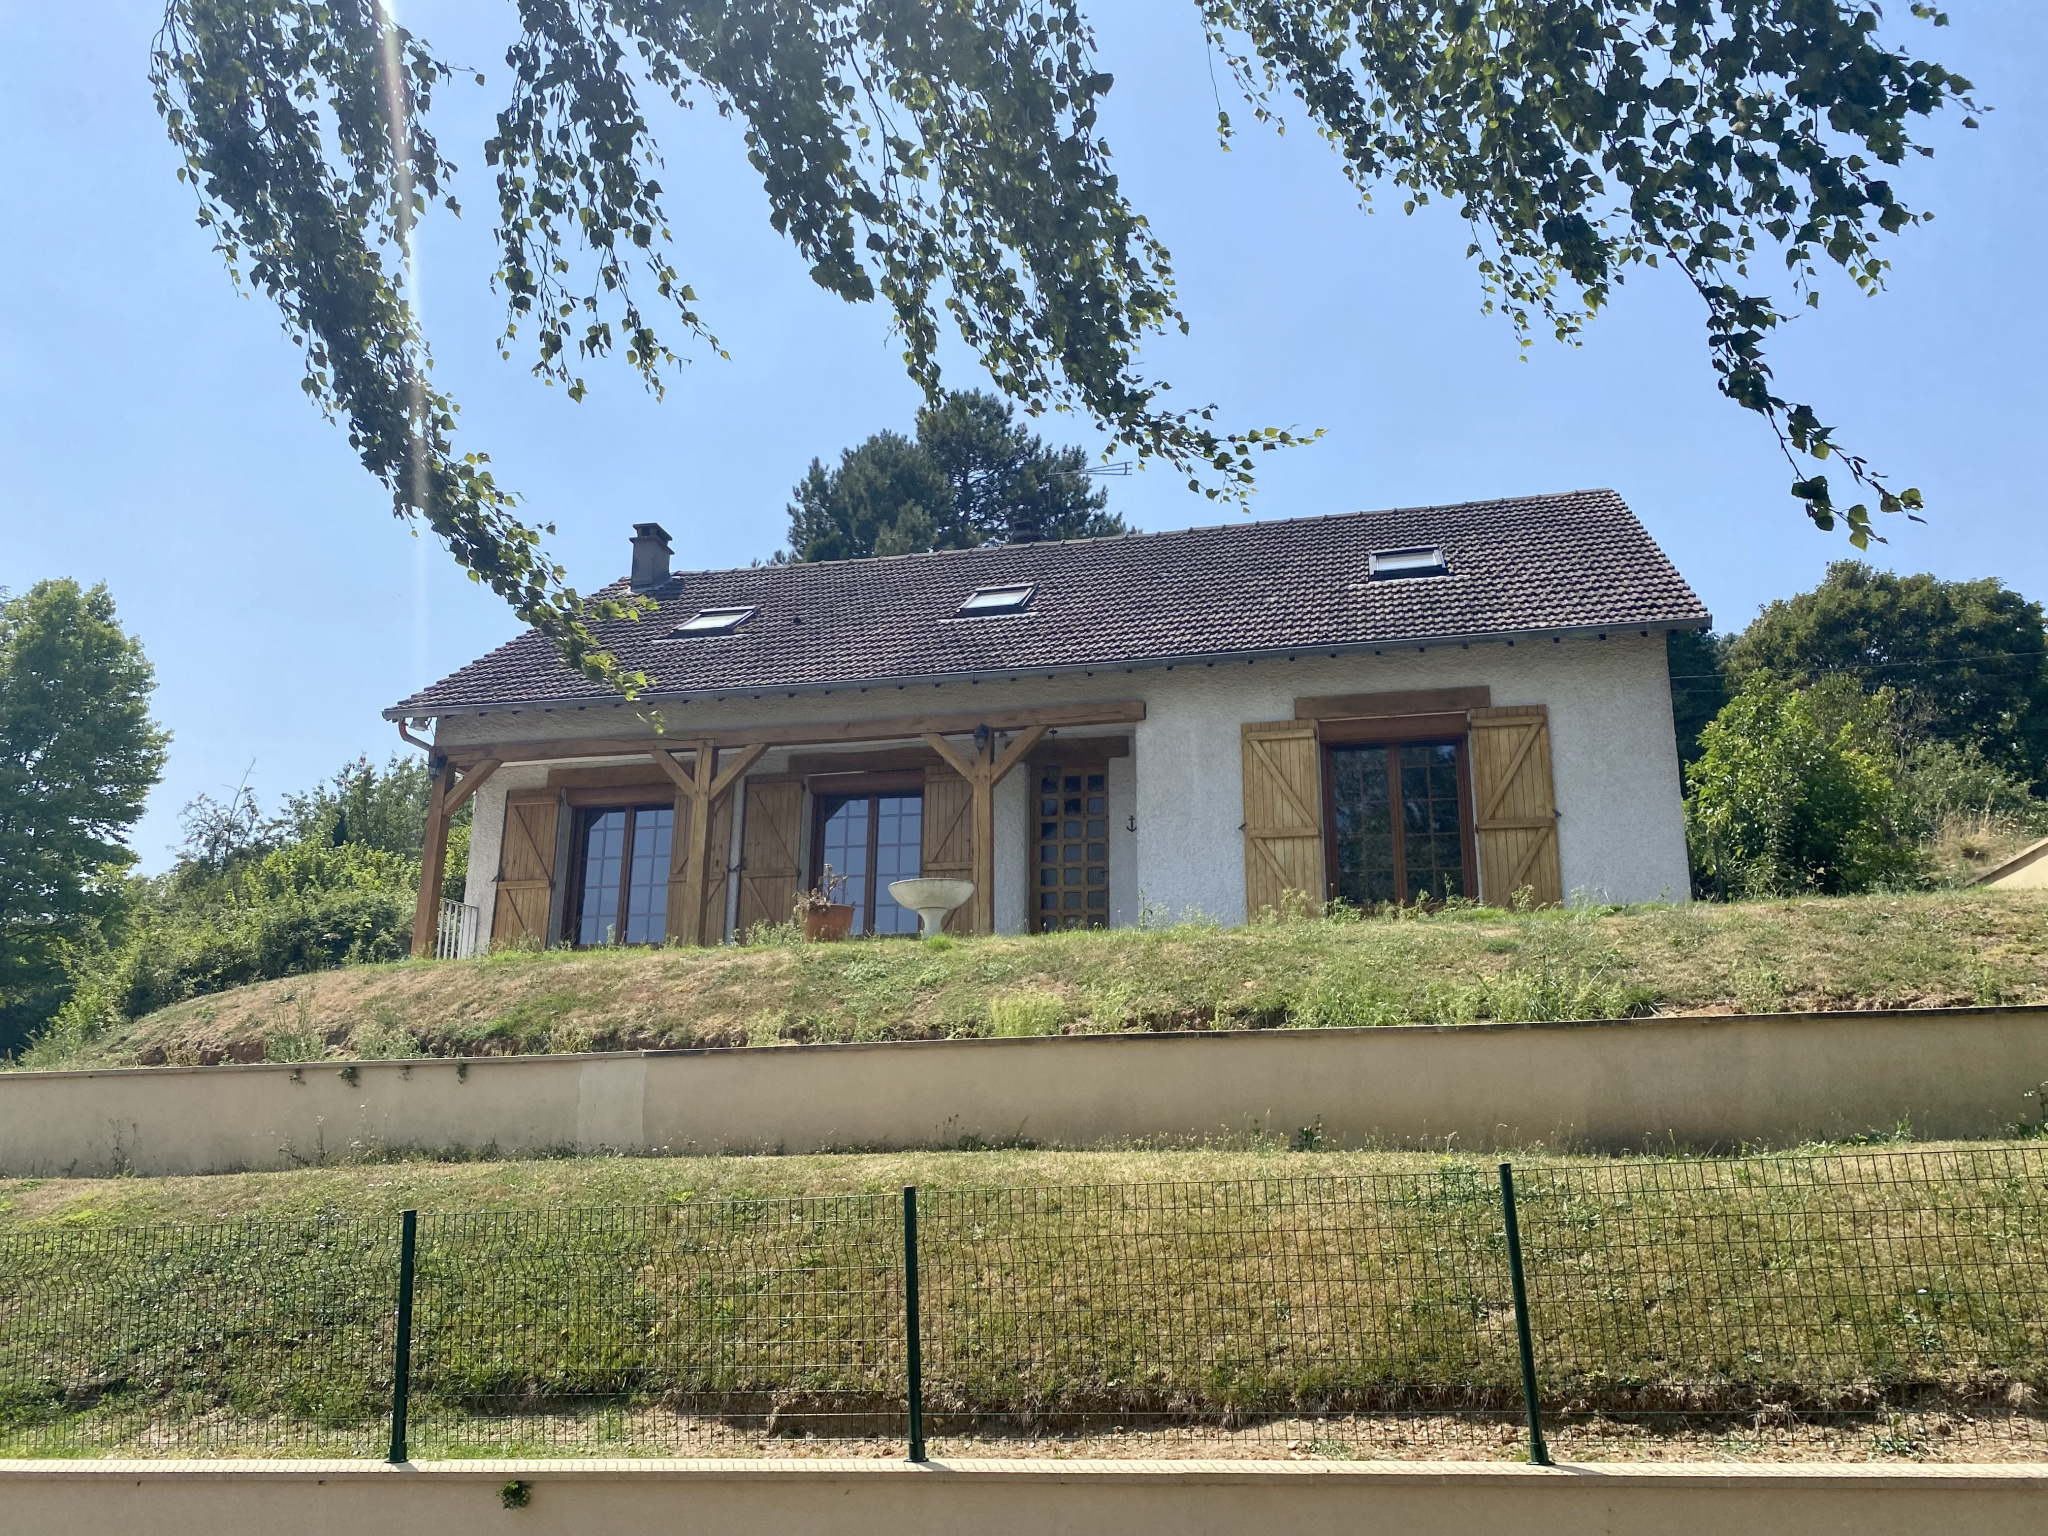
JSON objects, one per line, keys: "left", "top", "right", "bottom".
{"left": 438, "top": 633, "right": 1688, "bottom": 932}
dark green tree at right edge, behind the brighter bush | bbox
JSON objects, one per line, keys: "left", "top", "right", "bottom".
{"left": 1726, "top": 561, "right": 2048, "bottom": 782}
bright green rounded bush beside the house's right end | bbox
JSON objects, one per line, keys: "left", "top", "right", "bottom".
{"left": 1686, "top": 672, "right": 1917, "bottom": 897}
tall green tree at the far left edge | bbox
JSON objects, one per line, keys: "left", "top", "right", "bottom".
{"left": 0, "top": 582, "right": 168, "bottom": 1055}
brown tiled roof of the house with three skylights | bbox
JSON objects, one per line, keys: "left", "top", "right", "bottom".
{"left": 385, "top": 492, "right": 1708, "bottom": 719}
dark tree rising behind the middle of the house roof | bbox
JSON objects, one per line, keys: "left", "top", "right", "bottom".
{"left": 788, "top": 389, "right": 1126, "bottom": 559}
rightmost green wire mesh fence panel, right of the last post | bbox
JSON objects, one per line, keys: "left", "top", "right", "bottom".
{"left": 1516, "top": 1147, "right": 2048, "bottom": 1460}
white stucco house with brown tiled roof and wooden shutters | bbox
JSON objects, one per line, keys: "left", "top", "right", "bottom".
{"left": 387, "top": 492, "right": 1710, "bottom": 954}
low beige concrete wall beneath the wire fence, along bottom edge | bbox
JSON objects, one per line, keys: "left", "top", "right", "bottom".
{"left": 0, "top": 1460, "right": 2048, "bottom": 1536}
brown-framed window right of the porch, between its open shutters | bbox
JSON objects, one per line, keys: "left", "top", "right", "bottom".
{"left": 1325, "top": 741, "right": 1475, "bottom": 907}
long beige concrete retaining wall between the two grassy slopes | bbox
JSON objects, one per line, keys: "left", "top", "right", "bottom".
{"left": 0, "top": 1008, "right": 2048, "bottom": 1176}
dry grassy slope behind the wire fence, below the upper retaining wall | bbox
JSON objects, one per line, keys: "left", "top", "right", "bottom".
{"left": 0, "top": 1143, "right": 2048, "bottom": 1454}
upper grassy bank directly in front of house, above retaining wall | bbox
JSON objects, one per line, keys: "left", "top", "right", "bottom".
{"left": 37, "top": 891, "right": 2048, "bottom": 1065}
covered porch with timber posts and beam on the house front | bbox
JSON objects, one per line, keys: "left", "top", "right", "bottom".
{"left": 412, "top": 700, "right": 1145, "bottom": 958}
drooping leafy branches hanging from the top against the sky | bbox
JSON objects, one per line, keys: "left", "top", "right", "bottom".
{"left": 152, "top": 0, "right": 1974, "bottom": 690}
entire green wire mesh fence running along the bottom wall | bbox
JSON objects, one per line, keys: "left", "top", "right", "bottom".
{"left": 0, "top": 1147, "right": 2048, "bottom": 1460}
